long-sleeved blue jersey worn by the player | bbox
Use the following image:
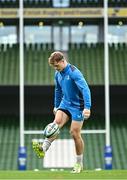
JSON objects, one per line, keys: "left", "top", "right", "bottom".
{"left": 54, "top": 64, "right": 91, "bottom": 109}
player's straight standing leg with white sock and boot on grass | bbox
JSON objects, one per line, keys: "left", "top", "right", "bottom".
{"left": 70, "top": 121, "right": 84, "bottom": 173}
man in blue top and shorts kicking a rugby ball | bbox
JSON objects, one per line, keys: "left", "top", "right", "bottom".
{"left": 33, "top": 51, "right": 91, "bottom": 173}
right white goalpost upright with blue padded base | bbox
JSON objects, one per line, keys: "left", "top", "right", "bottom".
{"left": 104, "top": 0, "right": 112, "bottom": 169}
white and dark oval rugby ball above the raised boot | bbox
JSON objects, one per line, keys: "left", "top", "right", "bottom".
{"left": 44, "top": 122, "right": 60, "bottom": 138}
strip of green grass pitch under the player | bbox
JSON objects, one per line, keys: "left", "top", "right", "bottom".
{"left": 0, "top": 170, "right": 127, "bottom": 180}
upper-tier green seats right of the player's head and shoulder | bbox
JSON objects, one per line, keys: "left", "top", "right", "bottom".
{"left": 68, "top": 43, "right": 127, "bottom": 85}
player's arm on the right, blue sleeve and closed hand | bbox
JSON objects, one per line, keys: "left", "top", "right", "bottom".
{"left": 72, "top": 70, "right": 91, "bottom": 118}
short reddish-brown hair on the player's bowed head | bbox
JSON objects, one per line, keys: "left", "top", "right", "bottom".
{"left": 48, "top": 51, "right": 65, "bottom": 64}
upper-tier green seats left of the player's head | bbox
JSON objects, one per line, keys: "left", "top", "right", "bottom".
{"left": 0, "top": 44, "right": 54, "bottom": 85}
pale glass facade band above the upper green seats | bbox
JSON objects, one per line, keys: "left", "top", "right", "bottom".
{"left": 0, "top": 22, "right": 127, "bottom": 47}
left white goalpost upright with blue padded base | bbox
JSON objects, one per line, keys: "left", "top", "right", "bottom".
{"left": 18, "top": 0, "right": 26, "bottom": 170}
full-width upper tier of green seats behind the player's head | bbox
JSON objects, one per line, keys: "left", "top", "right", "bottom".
{"left": 0, "top": 43, "right": 127, "bottom": 85}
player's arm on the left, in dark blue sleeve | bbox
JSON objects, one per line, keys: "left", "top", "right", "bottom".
{"left": 54, "top": 73, "right": 62, "bottom": 113}
